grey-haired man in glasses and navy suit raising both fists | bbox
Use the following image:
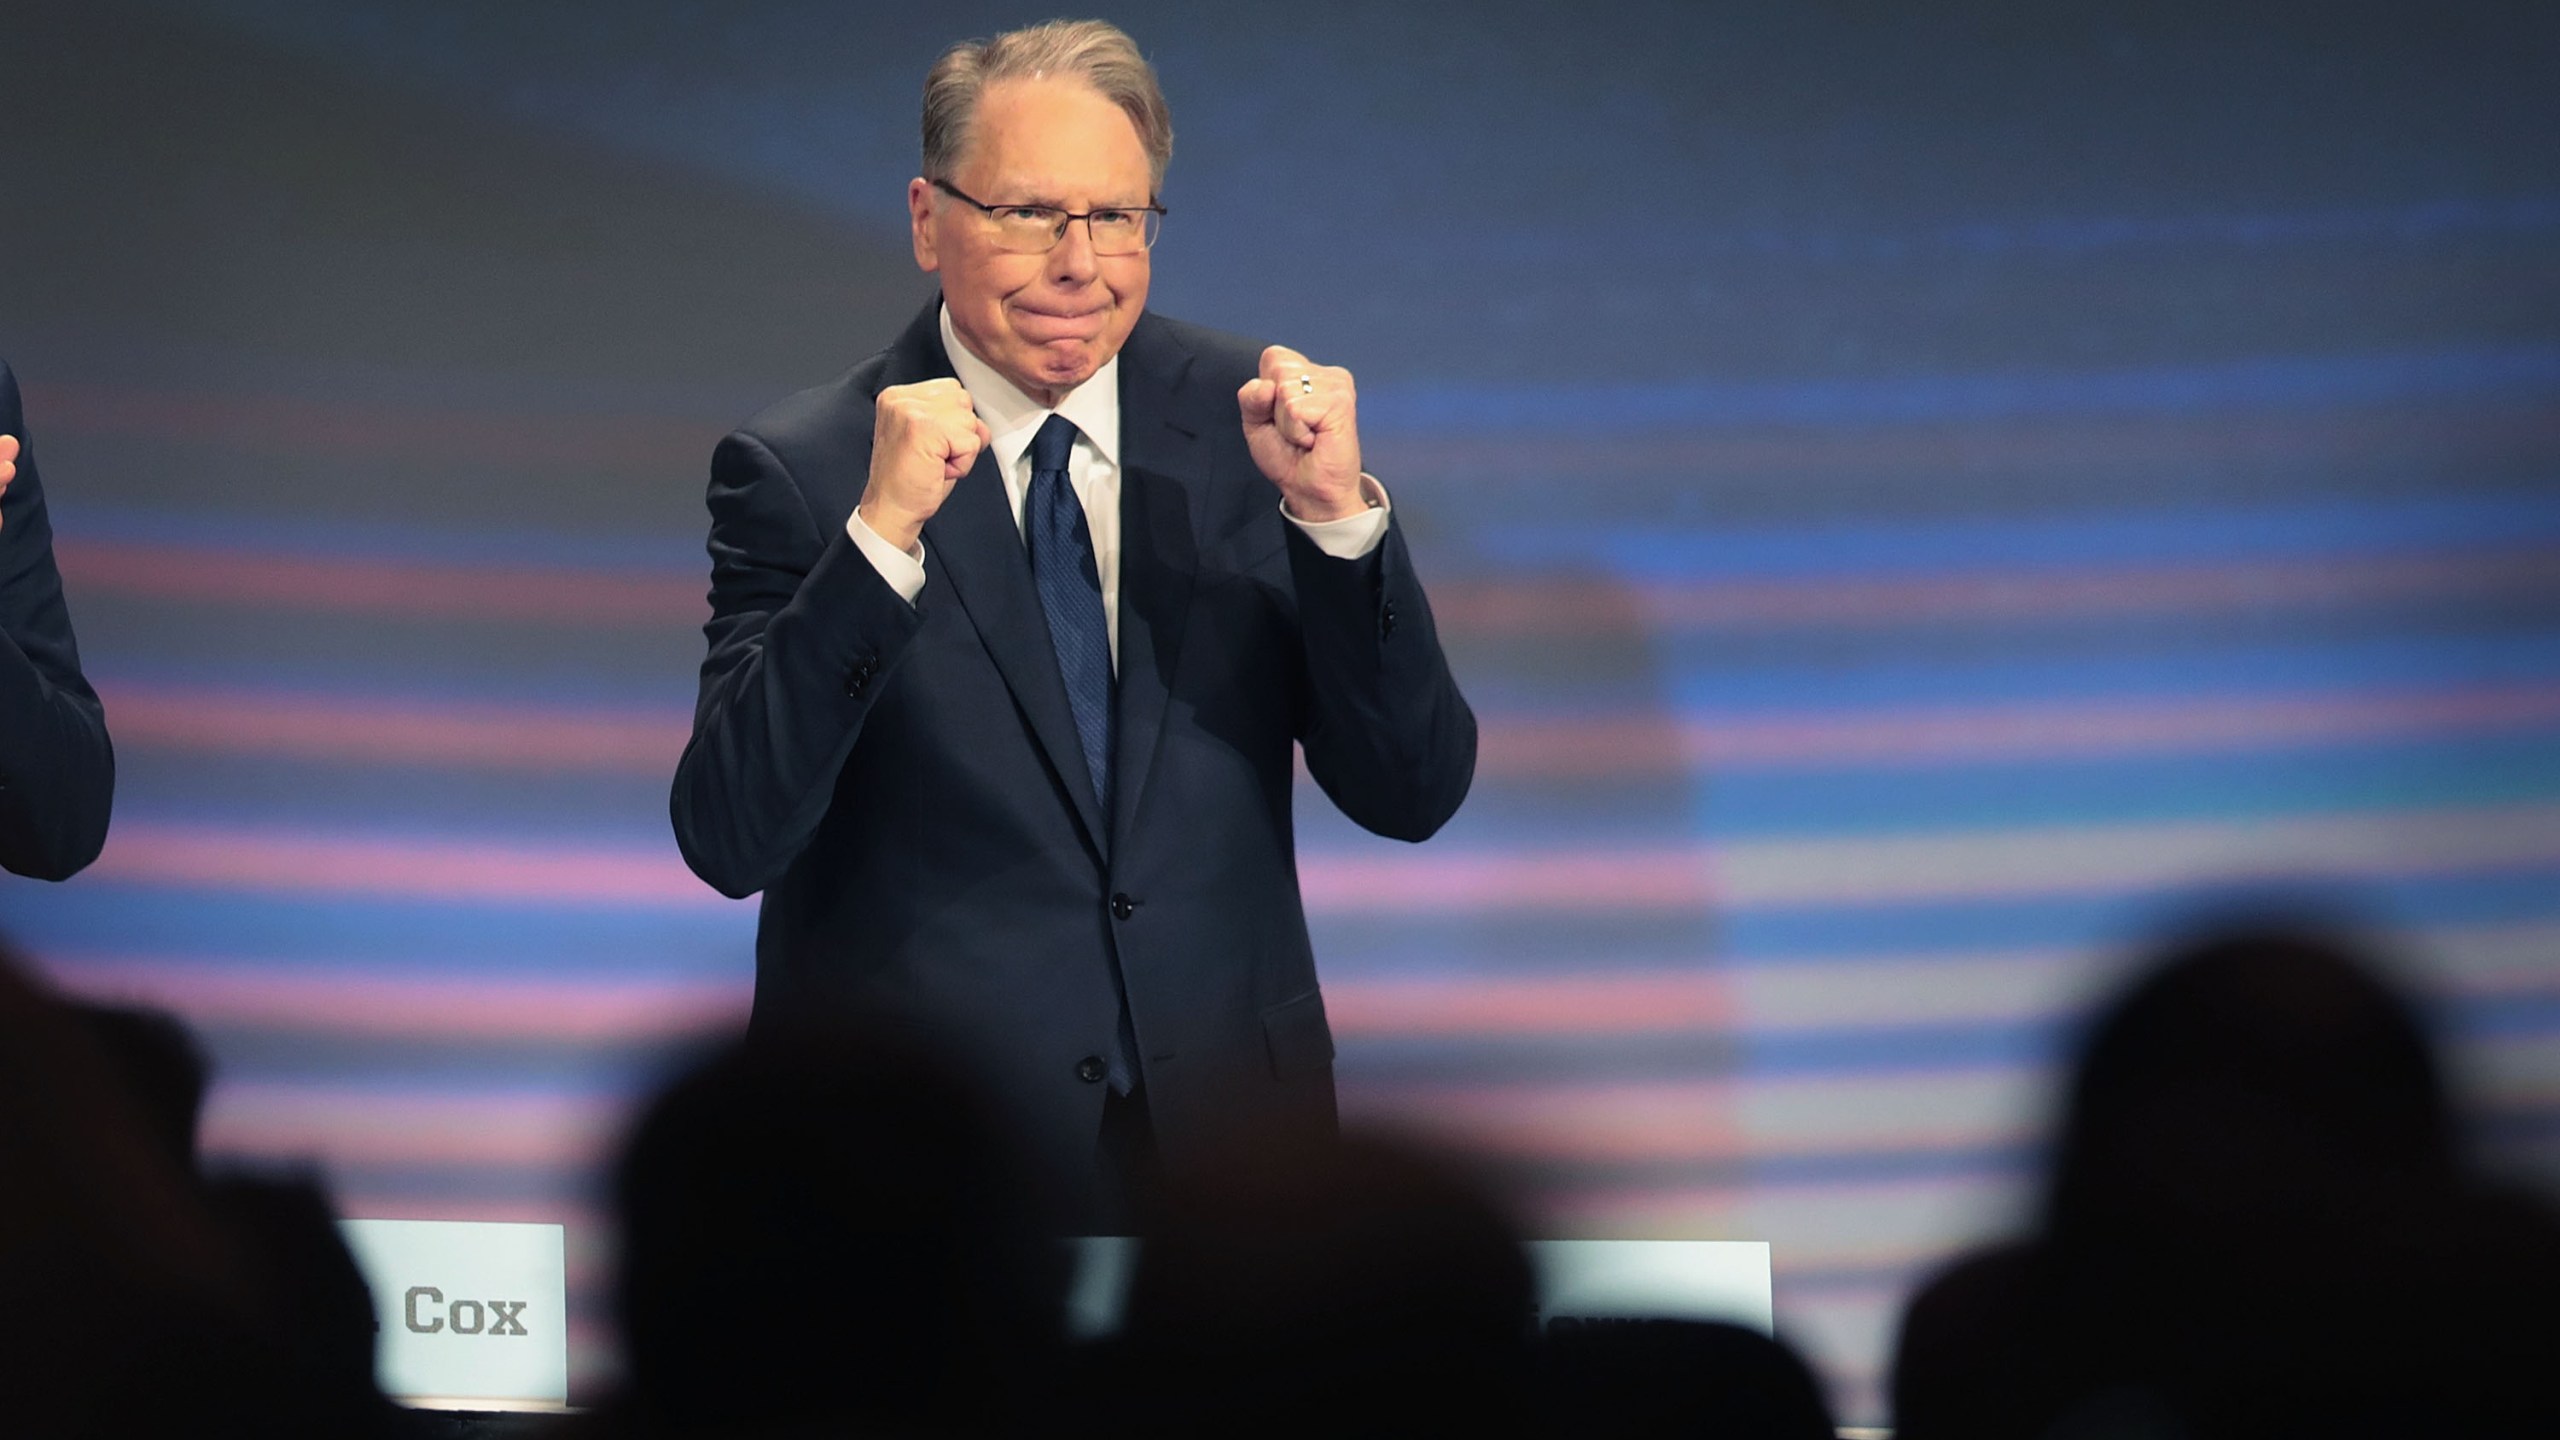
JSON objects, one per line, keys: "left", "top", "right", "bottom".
{"left": 673, "top": 20, "right": 1475, "bottom": 1220}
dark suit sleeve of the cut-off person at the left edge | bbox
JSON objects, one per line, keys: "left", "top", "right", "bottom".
{"left": 0, "top": 361, "right": 115, "bottom": 879}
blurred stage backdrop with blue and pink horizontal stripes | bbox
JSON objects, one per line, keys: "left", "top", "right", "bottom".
{"left": 0, "top": 0, "right": 2560, "bottom": 1417}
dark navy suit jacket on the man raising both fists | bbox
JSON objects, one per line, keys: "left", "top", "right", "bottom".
{"left": 673, "top": 305, "right": 1475, "bottom": 1199}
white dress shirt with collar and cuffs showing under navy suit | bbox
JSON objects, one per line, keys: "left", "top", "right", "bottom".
{"left": 845, "top": 305, "right": 1390, "bottom": 674}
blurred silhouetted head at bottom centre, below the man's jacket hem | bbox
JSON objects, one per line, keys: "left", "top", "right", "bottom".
{"left": 1121, "top": 1135, "right": 1536, "bottom": 1435}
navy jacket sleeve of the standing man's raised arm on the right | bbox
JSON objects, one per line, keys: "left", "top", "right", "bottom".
{"left": 1283, "top": 507, "right": 1475, "bottom": 840}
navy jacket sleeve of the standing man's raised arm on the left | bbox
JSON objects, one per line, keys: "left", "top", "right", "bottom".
{"left": 671, "top": 433, "right": 922, "bottom": 897}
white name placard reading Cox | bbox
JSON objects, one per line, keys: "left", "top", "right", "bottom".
{"left": 338, "top": 1220, "right": 568, "bottom": 1409}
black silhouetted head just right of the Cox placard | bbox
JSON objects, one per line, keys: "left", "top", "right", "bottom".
{"left": 614, "top": 1025, "right": 1062, "bottom": 1435}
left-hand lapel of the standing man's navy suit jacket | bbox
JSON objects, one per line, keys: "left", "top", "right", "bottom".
{"left": 906, "top": 297, "right": 1111, "bottom": 853}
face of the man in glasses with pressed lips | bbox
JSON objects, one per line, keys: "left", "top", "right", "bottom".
{"left": 906, "top": 77, "right": 1155, "bottom": 405}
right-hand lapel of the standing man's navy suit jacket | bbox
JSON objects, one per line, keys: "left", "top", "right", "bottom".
{"left": 1111, "top": 318, "right": 1206, "bottom": 840}
